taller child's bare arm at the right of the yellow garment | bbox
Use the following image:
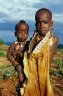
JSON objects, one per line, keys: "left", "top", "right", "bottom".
{"left": 50, "top": 37, "right": 58, "bottom": 64}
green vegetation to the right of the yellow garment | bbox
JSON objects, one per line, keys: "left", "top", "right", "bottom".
{"left": 50, "top": 47, "right": 63, "bottom": 79}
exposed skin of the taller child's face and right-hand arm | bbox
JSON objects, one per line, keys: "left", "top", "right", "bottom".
{"left": 35, "top": 11, "right": 58, "bottom": 63}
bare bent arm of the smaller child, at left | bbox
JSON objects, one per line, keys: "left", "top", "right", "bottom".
{"left": 7, "top": 43, "right": 19, "bottom": 66}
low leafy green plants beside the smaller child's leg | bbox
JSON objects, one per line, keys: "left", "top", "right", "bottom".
{"left": 0, "top": 64, "right": 17, "bottom": 79}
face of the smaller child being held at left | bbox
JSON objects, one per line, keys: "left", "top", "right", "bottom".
{"left": 17, "top": 24, "right": 28, "bottom": 42}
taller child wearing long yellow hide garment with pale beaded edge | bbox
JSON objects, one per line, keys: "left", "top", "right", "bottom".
{"left": 24, "top": 8, "right": 58, "bottom": 96}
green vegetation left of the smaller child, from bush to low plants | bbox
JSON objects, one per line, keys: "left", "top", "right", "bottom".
{"left": 0, "top": 49, "right": 17, "bottom": 79}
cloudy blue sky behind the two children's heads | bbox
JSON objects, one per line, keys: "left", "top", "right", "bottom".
{"left": 0, "top": 0, "right": 63, "bottom": 44}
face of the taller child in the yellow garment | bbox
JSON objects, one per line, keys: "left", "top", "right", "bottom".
{"left": 36, "top": 11, "right": 52, "bottom": 35}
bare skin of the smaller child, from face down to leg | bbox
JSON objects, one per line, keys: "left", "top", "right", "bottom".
{"left": 7, "top": 23, "right": 28, "bottom": 85}
